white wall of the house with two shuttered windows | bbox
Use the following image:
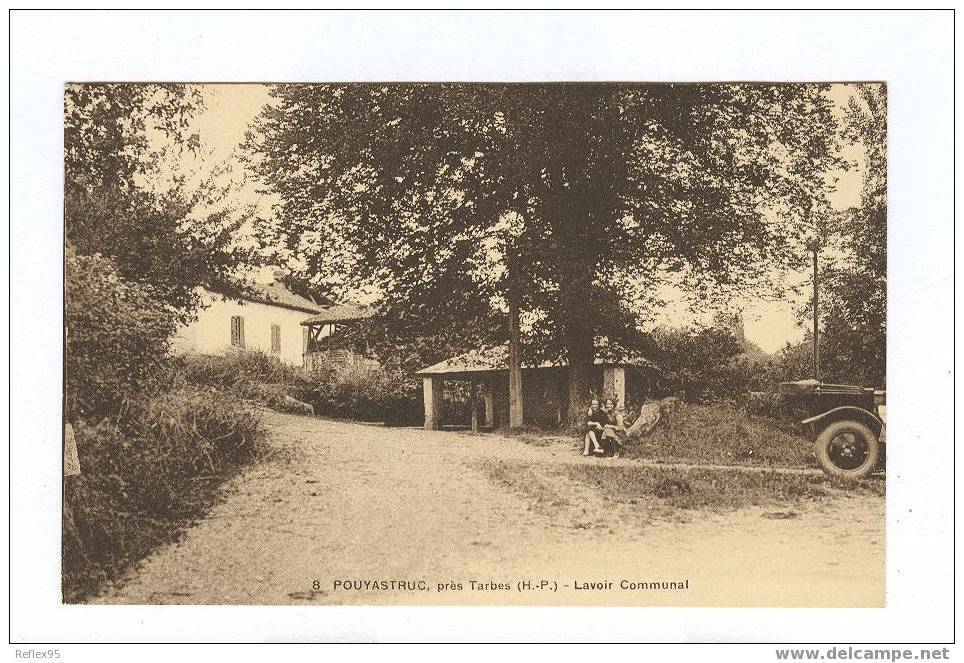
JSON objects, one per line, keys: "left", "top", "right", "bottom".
{"left": 171, "top": 290, "right": 322, "bottom": 366}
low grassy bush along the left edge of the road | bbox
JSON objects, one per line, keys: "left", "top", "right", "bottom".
{"left": 62, "top": 386, "right": 264, "bottom": 602}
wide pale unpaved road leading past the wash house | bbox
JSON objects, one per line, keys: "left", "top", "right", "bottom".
{"left": 92, "top": 413, "right": 884, "bottom": 606}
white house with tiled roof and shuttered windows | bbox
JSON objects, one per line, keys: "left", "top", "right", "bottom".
{"left": 172, "top": 281, "right": 325, "bottom": 366}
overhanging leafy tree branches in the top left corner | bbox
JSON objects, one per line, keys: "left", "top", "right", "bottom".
{"left": 64, "top": 84, "right": 251, "bottom": 320}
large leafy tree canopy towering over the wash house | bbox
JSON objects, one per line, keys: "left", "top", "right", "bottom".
{"left": 249, "top": 83, "right": 839, "bottom": 426}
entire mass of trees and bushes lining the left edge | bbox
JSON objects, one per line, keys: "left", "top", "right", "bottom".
{"left": 62, "top": 84, "right": 272, "bottom": 601}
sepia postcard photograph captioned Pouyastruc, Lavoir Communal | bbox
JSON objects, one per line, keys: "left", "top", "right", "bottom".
{"left": 60, "top": 80, "right": 888, "bottom": 608}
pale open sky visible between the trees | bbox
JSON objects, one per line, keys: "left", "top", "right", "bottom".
{"left": 179, "top": 83, "right": 862, "bottom": 352}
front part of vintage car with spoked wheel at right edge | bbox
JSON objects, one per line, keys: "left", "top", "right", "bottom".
{"left": 780, "top": 380, "right": 886, "bottom": 479}
